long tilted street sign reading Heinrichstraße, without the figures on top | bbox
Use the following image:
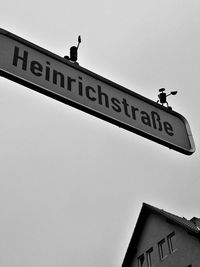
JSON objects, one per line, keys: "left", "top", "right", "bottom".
{"left": 0, "top": 29, "right": 195, "bottom": 155}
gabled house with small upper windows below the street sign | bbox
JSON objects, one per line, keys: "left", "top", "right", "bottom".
{"left": 122, "top": 203, "right": 200, "bottom": 267}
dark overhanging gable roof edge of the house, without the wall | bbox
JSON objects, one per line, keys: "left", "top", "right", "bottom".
{"left": 122, "top": 203, "right": 200, "bottom": 267}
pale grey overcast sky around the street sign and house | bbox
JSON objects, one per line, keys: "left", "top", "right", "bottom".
{"left": 0, "top": 0, "right": 200, "bottom": 267}
